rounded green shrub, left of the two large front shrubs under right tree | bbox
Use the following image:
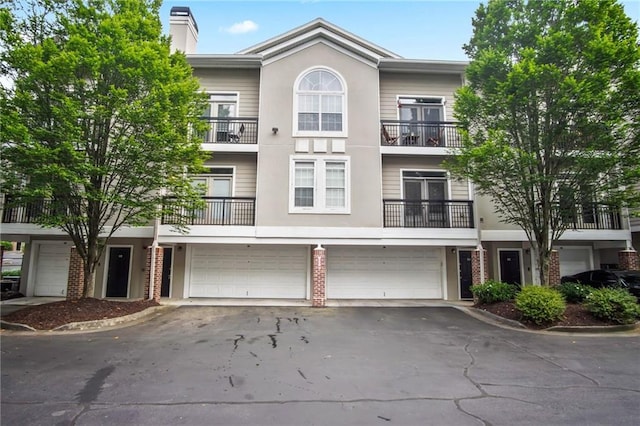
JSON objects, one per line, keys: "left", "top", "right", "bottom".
{"left": 516, "top": 286, "right": 567, "bottom": 325}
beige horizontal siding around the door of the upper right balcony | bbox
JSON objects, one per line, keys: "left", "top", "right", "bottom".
{"left": 380, "top": 72, "right": 462, "bottom": 121}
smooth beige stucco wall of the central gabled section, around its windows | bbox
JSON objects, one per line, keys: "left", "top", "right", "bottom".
{"left": 256, "top": 43, "right": 382, "bottom": 227}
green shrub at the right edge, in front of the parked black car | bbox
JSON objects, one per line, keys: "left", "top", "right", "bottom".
{"left": 585, "top": 288, "right": 640, "bottom": 324}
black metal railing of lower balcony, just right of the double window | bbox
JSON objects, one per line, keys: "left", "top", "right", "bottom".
{"left": 382, "top": 200, "right": 474, "bottom": 228}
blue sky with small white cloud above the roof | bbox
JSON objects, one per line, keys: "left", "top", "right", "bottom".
{"left": 160, "top": 0, "right": 640, "bottom": 61}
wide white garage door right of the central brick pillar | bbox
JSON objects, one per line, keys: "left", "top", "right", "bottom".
{"left": 327, "top": 247, "right": 442, "bottom": 299}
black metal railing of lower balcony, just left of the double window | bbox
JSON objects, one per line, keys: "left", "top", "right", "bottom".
{"left": 162, "top": 197, "right": 256, "bottom": 226}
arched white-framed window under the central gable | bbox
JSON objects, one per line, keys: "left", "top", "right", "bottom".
{"left": 296, "top": 69, "right": 345, "bottom": 134}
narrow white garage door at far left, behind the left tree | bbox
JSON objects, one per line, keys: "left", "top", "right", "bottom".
{"left": 33, "top": 243, "right": 71, "bottom": 296}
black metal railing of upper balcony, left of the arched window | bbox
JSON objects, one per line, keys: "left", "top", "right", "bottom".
{"left": 203, "top": 117, "right": 258, "bottom": 144}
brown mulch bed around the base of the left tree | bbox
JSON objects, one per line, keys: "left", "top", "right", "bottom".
{"left": 2, "top": 297, "right": 159, "bottom": 330}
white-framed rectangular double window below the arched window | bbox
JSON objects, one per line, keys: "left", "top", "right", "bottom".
{"left": 289, "top": 156, "right": 350, "bottom": 214}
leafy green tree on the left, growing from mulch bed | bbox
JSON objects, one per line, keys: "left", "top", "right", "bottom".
{"left": 0, "top": 0, "right": 203, "bottom": 297}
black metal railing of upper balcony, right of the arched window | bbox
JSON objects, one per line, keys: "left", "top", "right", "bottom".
{"left": 380, "top": 120, "right": 462, "bottom": 148}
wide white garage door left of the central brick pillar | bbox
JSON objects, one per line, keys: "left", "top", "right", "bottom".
{"left": 189, "top": 245, "right": 309, "bottom": 299}
